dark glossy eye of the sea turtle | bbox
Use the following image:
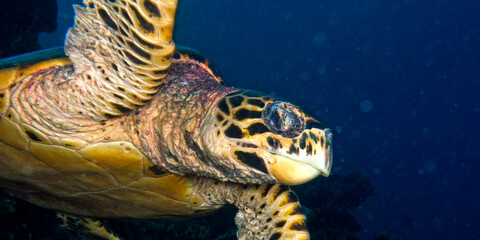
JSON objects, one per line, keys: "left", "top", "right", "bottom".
{"left": 262, "top": 102, "right": 305, "bottom": 138}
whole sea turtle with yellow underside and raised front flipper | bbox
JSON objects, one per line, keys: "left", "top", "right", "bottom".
{"left": 0, "top": 0, "right": 332, "bottom": 239}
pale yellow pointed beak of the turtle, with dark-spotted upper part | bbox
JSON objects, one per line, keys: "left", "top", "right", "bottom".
{"left": 267, "top": 129, "right": 332, "bottom": 185}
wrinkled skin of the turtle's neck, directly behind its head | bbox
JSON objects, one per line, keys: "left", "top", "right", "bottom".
{"left": 132, "top": 53, "right": 244, "bottom": 180}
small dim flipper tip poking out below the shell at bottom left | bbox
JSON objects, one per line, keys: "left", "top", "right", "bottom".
{"left": 57, "top": 213, "right": 122, "bottom": 240}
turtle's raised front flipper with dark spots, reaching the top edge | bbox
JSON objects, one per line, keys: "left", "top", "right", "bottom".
{"left": 64, "top": 0, "right": 177, "bottom": 120}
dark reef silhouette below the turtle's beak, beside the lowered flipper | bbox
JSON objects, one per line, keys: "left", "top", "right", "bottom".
{"left": 295, "top": 172, "right": 374, "bottom": 240}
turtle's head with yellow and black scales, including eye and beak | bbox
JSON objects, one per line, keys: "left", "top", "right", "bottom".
{"left": 203, "top": 90, "right": 332, "bottom": 185}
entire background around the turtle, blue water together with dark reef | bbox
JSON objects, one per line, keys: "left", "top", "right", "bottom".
{"left": 0, "top": 0, "right": 480, "bottom": 240}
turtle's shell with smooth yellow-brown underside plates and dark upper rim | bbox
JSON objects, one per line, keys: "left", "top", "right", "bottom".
{"left": 0, "top": 47, "right": 220, "bottom": 218}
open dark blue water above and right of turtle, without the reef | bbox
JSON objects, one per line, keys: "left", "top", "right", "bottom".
{"left": 3, "top": 0, "right": 480, "bottom": 239}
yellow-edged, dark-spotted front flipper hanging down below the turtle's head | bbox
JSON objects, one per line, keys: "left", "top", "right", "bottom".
{"left": 197, "top": 179, "right": 310, "bottom": 240}
